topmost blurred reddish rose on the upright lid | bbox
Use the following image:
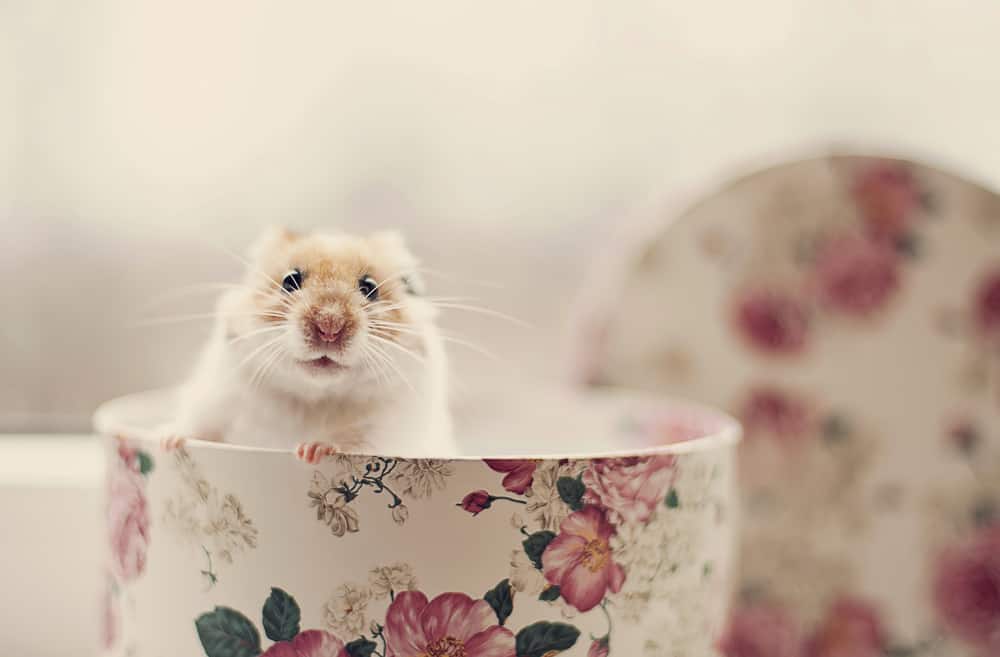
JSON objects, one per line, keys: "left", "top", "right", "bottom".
{"left": 852, "top": 162, "right": 920, "bottom": 242}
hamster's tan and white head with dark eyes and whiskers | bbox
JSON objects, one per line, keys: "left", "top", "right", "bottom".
{"left": 227, "top": 228, "right": 435, "bottom": 395}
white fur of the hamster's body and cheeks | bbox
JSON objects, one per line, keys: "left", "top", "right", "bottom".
{"left": 165, "top": 231, "right": 454, "bottom": 456}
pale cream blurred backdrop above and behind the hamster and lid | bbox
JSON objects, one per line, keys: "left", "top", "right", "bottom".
{"left": 0, "top": 0, "right": 1000, "bottom": 430}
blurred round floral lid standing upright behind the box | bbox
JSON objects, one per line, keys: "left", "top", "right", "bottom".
{"left": 574, "top": 156, "right": 1000, "bottom": 657}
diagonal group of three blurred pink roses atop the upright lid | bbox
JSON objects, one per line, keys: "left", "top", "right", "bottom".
{"left": 724, "top": 161, "right": 929, "bottom": 356}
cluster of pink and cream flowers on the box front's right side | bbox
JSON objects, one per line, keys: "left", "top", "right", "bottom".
{"left": 459, "top": 446, "right": 724, "bottom": 655}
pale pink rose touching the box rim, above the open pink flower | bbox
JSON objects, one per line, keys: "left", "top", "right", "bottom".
{"left": 583, "top": 456, "right": 676, "bottom": 523}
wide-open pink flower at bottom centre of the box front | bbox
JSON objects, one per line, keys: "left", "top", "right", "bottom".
{"left": 385, "top": 591, "right": 515, "bottom": 657}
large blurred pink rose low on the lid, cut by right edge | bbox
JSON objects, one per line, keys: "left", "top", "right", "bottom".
{"left": 934, "top": 525, "right": 1000, "bottom": 655}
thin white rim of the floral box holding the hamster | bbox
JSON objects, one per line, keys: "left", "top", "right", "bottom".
{"left": 93, "top": 387, "right": 743, "bottom": 461}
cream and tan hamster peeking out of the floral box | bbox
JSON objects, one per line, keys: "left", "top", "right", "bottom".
{"left": 163, "top": 227, "right": 454, "bottom": 463}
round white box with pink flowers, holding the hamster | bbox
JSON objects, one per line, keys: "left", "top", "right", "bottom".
{"left": 96, "top": 384, "right": 740, "bottom": 657}
